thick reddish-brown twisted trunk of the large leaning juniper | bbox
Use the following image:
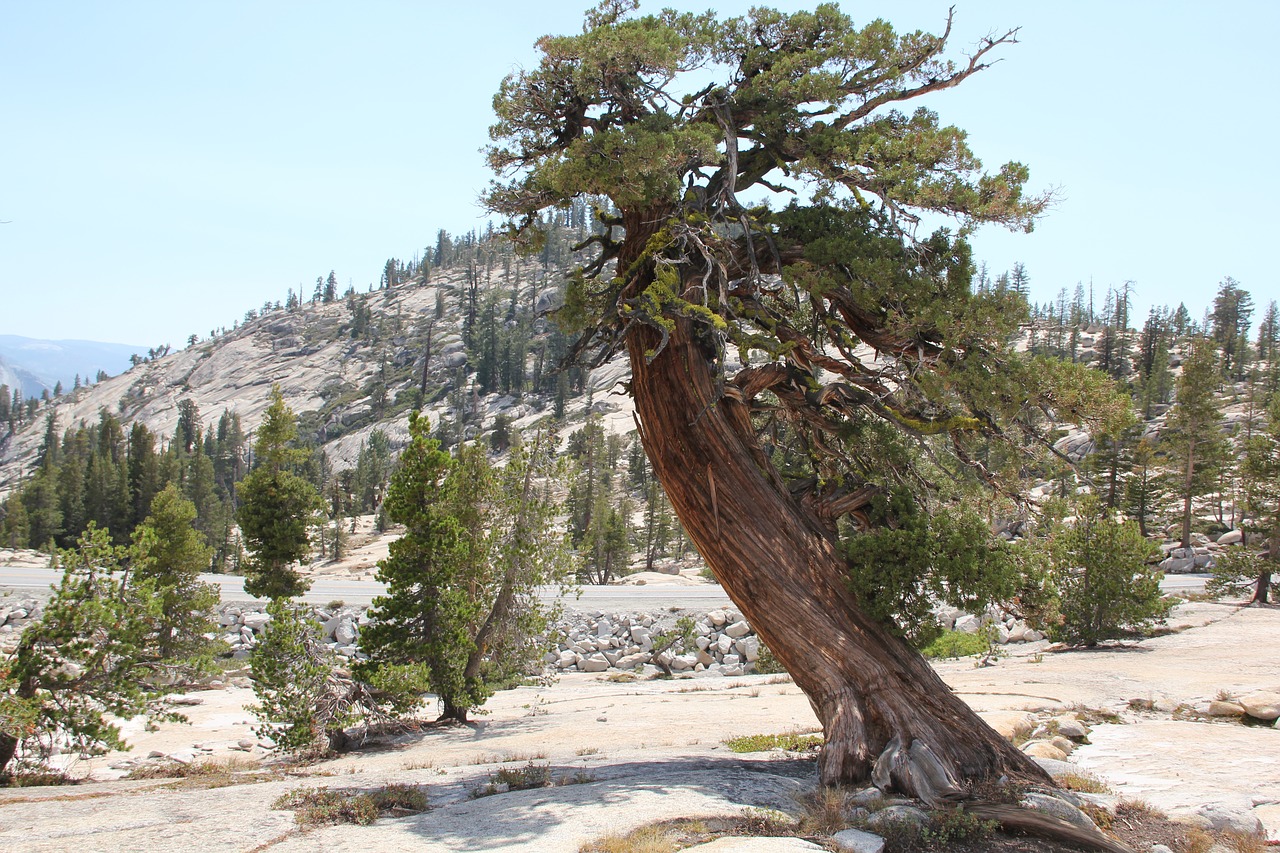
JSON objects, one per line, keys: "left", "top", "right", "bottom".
{"left": 627, "top": 313, "right": 1051, "bottom": 802}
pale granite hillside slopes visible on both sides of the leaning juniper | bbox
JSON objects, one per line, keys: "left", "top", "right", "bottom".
{"left": 0, "top": 239, "right": 1261, "bottom": 570}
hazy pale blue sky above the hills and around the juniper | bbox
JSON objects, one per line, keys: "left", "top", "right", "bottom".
{"left": 0, "top": 0, "right": 1280, "bottom": 346}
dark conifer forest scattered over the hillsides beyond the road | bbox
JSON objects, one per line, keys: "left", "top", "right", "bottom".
{"left": 0, "top": 210, "right": 1280, "bottom": 591}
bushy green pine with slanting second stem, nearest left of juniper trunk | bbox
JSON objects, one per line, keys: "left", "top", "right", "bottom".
{"left": 361, "top": 412, "right": 570, "bottom": 721}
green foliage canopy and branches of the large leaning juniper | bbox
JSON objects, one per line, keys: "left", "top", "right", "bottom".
{"left": 486, "top": 0, "right": 1128, "bottom": 640}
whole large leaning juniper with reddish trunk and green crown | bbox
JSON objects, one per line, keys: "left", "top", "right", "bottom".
{"left": 485, "top": 0, "right": 1131, "bottom": 802}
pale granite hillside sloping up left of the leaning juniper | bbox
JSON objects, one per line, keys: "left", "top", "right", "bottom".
{"left": 0, "top": 249, "right": 634, "bottom": 498}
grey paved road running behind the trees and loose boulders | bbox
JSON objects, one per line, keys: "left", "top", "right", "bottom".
{"left": 0, "top": 566, "right": 1210, "bottom": 611}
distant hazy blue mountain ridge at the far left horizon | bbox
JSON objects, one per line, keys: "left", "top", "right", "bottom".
{"left": 0, "top": 334, "right": 146, "bottom": 397}
